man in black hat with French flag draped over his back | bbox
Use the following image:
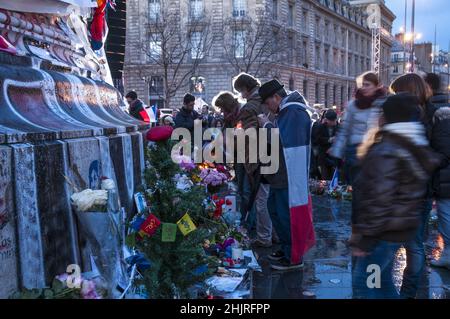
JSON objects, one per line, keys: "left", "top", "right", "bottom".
{"left": 259, "top": 80, "right": 315, "bottom": 270}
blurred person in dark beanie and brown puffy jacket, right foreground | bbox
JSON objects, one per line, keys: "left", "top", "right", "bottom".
{"left": 350, "top": 94, "right": 441, "bottom": 298}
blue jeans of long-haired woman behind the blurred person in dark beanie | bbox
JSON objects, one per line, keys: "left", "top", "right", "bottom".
{"left": 400, "top": 199, "right": 432, "bottom": 298}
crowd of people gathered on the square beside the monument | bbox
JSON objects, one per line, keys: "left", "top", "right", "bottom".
{"left": 127, "top": 72, "right": 450, "bottom": 298}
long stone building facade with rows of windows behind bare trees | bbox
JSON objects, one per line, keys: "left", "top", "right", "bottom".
{"left": 124, "top": 0, "right": 395, "bottom": 108}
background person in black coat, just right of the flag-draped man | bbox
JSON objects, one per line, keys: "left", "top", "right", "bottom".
{"left": 313, "top": 110, "right": 338, "bottom": 180}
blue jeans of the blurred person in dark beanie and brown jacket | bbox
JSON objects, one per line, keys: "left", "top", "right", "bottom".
{"left": 352, "top": 241, "right": 401, "bottom": 299}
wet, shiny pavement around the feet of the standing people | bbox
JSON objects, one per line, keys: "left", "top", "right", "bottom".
{"left": 253, "top": 196, "right": 450, "bottom": 299}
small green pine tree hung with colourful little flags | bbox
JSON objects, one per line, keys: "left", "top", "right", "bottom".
{"left": 131, "top": 128, "right": 215, "bottom": 299}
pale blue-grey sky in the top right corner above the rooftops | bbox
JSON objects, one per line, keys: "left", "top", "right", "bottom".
{"left": 385, "top": 0, "right": 450, "bottom": 51}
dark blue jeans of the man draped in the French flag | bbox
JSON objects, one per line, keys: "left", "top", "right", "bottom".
{"left": 267, "top": 187, "right": 292, "bottom": 260}
